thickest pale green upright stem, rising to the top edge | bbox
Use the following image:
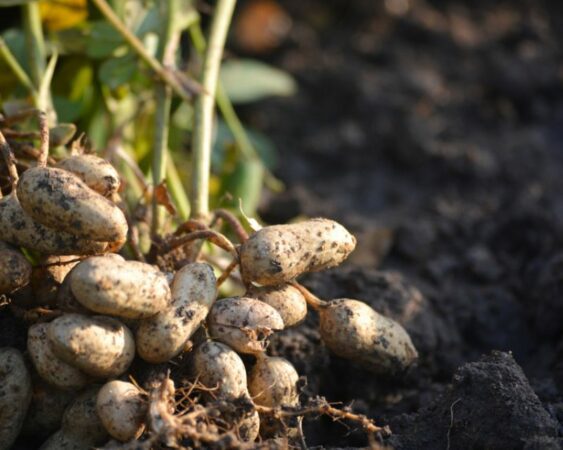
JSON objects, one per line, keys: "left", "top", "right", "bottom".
{"left": 190, "top": 0, "right": 236, "bottom": 219}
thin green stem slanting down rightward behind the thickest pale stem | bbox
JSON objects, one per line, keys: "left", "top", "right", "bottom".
{"left": 190, "top": 22, "right": 283, "bottom": 192}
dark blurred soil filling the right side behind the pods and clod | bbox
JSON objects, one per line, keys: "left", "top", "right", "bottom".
{"left": 244, "top": 0, "right": 563, "bottom": 449}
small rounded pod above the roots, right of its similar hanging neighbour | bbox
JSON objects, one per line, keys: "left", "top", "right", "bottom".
{"left": 248, "top": 356, "right": 299, "bottom": 407}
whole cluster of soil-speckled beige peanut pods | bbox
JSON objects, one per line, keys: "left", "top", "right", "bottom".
{"left": 0, "top": 118, "right": 417, "bottom": 450}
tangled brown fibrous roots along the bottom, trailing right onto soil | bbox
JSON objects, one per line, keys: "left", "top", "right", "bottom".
{"left": 110, "top": 378, "right": 391, "bottom": 450}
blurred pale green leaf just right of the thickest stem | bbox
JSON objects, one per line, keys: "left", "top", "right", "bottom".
{"left": 221, "top": 59, "right": 297, "bottom": 103}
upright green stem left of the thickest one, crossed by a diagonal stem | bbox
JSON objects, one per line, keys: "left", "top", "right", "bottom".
{"left": 151, "top": 0, "right": 179, "bottom": 236}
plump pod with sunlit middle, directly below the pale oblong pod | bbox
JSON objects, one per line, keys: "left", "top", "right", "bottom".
{"left": 47, "top": 314, "right": 135, "bottom": 378}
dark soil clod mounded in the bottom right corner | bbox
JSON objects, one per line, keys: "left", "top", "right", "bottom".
{"left": 389, "top": 352, "right": 558, "bottom": 450}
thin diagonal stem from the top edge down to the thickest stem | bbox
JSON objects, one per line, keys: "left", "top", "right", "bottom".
{"left": 92, "top": 0, "right": 201, "bottom": 102}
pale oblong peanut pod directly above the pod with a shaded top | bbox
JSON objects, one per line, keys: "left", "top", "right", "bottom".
{"left": 70, "top": 256, "right": 170, "bottom": 319}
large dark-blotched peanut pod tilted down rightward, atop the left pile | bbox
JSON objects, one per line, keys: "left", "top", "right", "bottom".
{"left": 17, "top": 167, "right": 128, "bottom": 242}
